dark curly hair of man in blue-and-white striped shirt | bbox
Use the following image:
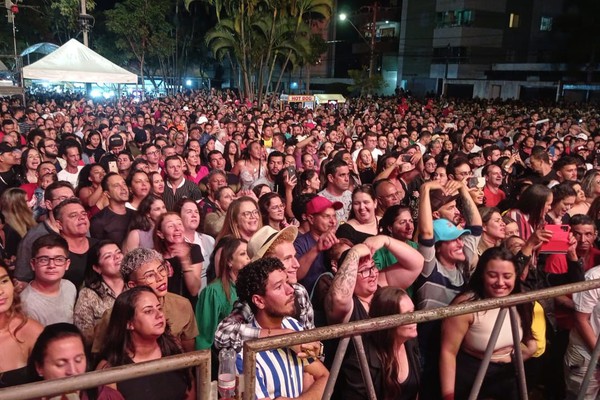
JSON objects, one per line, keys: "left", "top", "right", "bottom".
{"left": 236, "top": 257, "right": 285, "bottom": 314}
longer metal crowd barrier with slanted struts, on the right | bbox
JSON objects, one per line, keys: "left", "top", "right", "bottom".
{"left": 243, "top": 279, "right": 600, "bottom": 400}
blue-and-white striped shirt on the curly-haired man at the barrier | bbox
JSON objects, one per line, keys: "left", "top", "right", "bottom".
{"left": 236, "top": 317, "right": 313, "bottom": 399}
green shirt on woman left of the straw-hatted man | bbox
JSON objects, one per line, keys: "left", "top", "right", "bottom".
{"left": 196, "top": 280, "right": 238, "bottom": 350}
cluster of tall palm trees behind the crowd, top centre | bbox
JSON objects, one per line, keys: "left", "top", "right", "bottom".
{"left": 193, "top": 0, "right": 332, "bottom": 103}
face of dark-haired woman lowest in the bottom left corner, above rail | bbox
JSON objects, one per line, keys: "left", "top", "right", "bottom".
{"left": 35, "top": 336, "right": 87, "bottom": 380}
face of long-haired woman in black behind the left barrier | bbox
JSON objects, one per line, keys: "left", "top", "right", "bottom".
{"left": 127, "top": 292, "right": 167, "bottom": 339}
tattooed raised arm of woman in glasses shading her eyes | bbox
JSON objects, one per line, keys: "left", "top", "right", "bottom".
{"left": 325, "top": 243, "right": 371, "bottom": 324}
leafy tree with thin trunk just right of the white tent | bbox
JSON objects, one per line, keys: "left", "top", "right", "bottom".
{"left": 105, "top": 0, "right": 174, "bottom": 90}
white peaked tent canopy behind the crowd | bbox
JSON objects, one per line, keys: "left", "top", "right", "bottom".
{"left": 23, "top": 39, "right": 138, "bottom": 83}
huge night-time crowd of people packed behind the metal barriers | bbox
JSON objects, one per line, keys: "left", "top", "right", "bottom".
{"left": 0, "top": 89, "right": 600, "bottom": 400}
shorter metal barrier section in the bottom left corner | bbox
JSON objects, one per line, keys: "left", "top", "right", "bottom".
{"left": 0, "top": 350, "right": 211, "bottom": 400}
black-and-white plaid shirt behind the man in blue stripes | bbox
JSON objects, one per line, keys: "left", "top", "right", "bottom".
{"left": 214, "top": 283, "right": 315, "bottom": 352}
